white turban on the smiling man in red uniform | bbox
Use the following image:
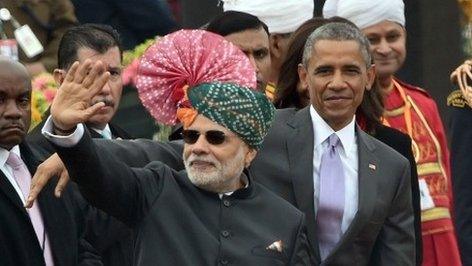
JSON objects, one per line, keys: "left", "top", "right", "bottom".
{"left": 323, "top": 0, "right": 405, "bottom": 29}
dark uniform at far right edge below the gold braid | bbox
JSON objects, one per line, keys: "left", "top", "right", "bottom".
{"left": 449, "top": 105, "right": 472, "bottom": 265}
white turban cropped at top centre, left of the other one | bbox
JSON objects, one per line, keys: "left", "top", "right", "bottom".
{"left": 222, "top": 0, "right": 316, "bottom": 34}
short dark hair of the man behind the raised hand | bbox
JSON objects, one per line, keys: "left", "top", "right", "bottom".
{"left": 57, "top": 23, "right": 123, "bottom": 69}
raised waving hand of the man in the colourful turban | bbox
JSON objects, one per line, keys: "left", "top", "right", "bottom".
{"left": 51, "top": 59, "right": 110, "bottom": 131}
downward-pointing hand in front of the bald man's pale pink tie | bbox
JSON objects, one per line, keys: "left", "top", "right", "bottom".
{"left": 25, "top": 153, "right": 69, "bottom": 208}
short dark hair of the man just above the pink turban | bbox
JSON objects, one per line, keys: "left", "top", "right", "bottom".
{"left": 206, "top": 11, "right": 269, "bottom": 36}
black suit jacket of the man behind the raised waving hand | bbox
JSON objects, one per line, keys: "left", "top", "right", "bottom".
{"left": 27, "top": 121, "right": 134, "bottom": 266}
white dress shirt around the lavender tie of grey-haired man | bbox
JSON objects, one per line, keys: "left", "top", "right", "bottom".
{"left": 310, "top": 106, "right": 359, "bottom": 233}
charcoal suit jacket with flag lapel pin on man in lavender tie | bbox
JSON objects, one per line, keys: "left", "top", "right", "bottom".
{"left": 91, "top": 108, "right": 415, "bottom": 265}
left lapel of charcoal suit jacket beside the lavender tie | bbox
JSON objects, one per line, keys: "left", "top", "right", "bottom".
{"left": 286, "top": 107, "right": 319, "bottom": 258}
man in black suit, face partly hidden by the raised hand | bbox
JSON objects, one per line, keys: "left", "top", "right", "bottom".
{"left": 27, "top": 24, "right": 134, "bottom": 265}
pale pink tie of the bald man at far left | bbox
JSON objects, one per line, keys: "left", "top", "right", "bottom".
{"left": 7, "top": 152, "right": 54, "bottom": 266}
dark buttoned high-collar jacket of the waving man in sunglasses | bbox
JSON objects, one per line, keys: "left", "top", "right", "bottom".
{"left": 57, "top": 132, "right": 313, "bottom": 266}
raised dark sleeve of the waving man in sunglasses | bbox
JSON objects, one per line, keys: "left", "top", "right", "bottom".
{"left": 53, "top": 132, "right": 166, "bottom": 226}
